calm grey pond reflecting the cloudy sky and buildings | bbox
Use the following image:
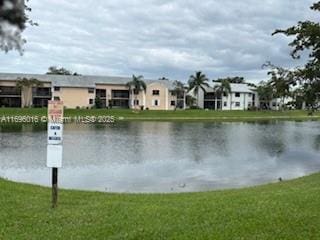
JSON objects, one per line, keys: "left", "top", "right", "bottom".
{"left": 0, "top": 121, "right": 320, "bottom": 193}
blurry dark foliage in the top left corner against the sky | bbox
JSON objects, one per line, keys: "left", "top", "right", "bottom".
{"left": 0, "top": 0, "right": 38, "bottom": 54}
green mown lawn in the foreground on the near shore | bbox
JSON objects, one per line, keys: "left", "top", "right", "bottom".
{"left": 0, "top": 174, "right": 320, "bottom": 240}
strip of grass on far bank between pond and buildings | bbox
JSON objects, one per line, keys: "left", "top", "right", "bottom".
{"left": 0, "top": 108, "right": 320, "bottom": 121}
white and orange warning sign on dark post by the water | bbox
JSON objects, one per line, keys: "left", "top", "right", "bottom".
{"left": 47, "top": 101, "right": 63, "bottom": 208}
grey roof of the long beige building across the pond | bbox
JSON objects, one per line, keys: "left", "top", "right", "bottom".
{"left": 0, "top": 73, "right": 174, "bottom": 90}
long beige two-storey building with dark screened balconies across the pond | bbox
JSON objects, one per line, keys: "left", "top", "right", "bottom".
{"left": 0, "top": 73, "right": 186, "bottom": 110}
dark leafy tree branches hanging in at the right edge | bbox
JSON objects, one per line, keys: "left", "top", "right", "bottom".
{"left": 273, "top": 1, "right": 320, "bottom": 111}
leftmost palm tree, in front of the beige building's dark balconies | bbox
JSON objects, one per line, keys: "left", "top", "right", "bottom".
{"left": 16, "top": 78, "right": 42, "bottom": 107}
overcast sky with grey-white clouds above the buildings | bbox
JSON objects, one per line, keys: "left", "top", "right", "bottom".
{"left": 0, "top": 0, "right": 317, "bottom": 82}
